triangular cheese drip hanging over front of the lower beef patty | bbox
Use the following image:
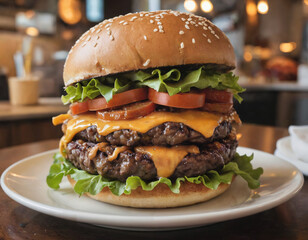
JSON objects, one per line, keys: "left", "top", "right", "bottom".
{"left": 135, "top": 145, "right": 200, "bottom": 177}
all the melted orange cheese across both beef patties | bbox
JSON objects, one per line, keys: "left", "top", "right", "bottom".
{"left": 53, "top": 110, "right": 241, "bottom": 177}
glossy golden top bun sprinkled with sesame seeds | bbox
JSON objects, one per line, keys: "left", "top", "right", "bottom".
{"left": 63, "top": 11, "right": 235, "bottom": 86}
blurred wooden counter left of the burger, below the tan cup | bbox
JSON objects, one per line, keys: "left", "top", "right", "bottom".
{"left": 0, "top": 98, "right": 68, "bottom": 148}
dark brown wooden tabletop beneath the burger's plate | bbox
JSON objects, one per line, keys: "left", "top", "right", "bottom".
{"left": 0, "top": 125, "right": 308, "bottom": 240}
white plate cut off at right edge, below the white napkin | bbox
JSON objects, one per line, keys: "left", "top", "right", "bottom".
{"left": 275, "top": 136, "right": 308, "bottom": 176}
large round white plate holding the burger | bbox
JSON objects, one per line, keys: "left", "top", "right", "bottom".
{"left": 1, "top": 147, "right": 303, "bottom": 230}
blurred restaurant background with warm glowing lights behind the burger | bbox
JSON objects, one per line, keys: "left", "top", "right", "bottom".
{"left": 0, "top": 0, "right": 308, "bottom": 147}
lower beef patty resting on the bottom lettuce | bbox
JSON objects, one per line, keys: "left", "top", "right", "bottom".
{"left": 66, "top": 137, "right": 237, "bottom": 182}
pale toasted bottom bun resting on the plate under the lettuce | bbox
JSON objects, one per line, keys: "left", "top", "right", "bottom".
{"left": 67, "top": 176, "right": 235, "bottom": 208}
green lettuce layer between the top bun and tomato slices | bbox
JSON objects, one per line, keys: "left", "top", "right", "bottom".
{"left": 62, "top": 67, "right": 245, "bottom": 104}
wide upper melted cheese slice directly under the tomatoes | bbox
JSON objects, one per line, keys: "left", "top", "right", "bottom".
{"left": 61, "top": 110, "right": 233, "bottom": 145}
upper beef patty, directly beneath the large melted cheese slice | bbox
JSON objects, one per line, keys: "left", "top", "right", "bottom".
{"left": 74, "top": 121, "right": 232, "bottom": 147}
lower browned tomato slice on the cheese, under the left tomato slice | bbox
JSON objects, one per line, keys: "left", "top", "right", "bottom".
{"left": 96, "top": 101, "right": 155, "bottom": 121}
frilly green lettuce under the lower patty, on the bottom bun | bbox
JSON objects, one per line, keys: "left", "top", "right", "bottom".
{"left": 46, "top": 153, "right": 263, "bottom": 196}
